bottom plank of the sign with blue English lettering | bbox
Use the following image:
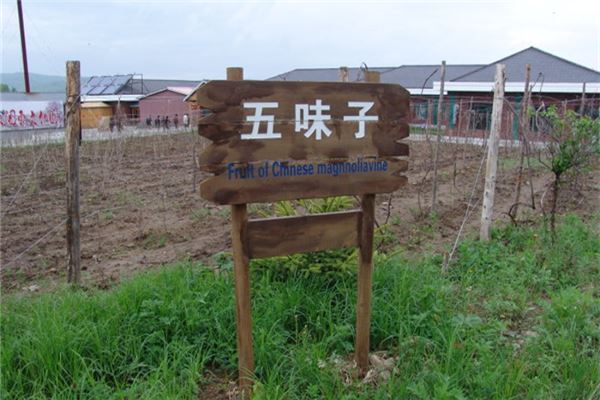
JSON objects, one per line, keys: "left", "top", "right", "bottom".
{"left": 200, "top": 159, "right": 408, "bottom": 204}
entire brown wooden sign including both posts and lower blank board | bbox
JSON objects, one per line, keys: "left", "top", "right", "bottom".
{"left": 192, "top": 68, "right": 409, "bottom": 397}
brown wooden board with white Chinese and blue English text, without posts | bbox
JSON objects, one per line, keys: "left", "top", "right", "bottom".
{"left": 195, "top": 81, "right": 409, "bottom": 204}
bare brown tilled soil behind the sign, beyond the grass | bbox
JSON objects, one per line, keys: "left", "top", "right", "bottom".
{"left": 0, "top": 134, "right": 600, "bottom": 291}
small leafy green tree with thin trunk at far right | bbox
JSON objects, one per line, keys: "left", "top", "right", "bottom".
{"left": 538, "top": 106, "right": 600, "bottom": 243}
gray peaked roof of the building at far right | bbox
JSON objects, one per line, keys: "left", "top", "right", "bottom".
{"left": 451, "top": 47, "right": 600, "bottom": 83}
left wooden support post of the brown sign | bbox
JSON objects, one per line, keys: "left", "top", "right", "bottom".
{"left": 227, "top": 67, "right": 254, "bottom": 399}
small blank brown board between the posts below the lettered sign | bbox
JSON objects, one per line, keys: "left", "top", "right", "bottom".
{"left": 247, "top": 210, "right": 362, "bottom": 258}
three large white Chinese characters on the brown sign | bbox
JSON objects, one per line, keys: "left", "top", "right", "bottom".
{"left": 241, "top": 99, "right": 379, "bottom": 140}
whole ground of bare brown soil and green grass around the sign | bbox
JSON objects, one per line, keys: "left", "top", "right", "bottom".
{"left": 1, "top": 130, "right": 600, "bottom": 399}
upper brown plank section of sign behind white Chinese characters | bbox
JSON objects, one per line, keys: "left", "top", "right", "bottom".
{"left": 196, "top": 81, "right": 409, "bottom": 171}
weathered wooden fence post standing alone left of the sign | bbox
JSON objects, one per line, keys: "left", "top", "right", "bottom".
{"left": 65, "top": 61, "right": 81, "bottom": 285}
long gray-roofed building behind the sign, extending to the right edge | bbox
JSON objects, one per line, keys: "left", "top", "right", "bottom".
{"left": 269, "top": 47, "right": 600, "bottom": 139}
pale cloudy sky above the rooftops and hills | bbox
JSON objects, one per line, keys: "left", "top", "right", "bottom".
{"left": 0, "top": 0, "right": 600, "bottom": 79}
